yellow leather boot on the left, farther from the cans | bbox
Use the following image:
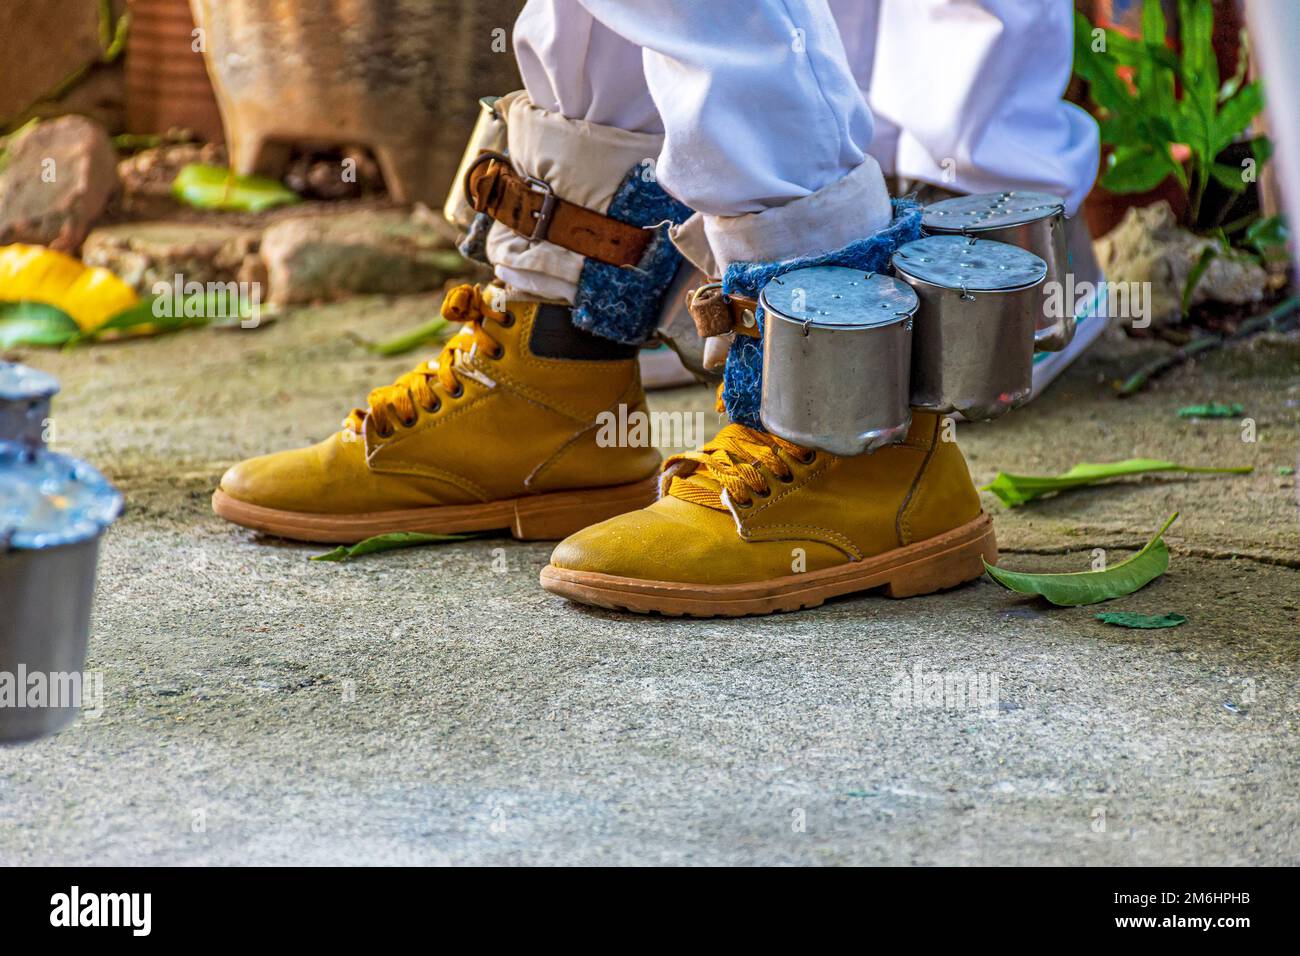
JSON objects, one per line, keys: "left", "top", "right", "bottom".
{"left": 212, "top": 286, "right": 659, "bottom": 544}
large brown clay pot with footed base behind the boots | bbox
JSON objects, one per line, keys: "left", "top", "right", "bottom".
{"left": 191, "top": 0, "right": 521, "bottom": 206}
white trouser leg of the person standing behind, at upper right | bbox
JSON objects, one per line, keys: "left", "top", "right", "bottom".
{"left": 831, "top": 0, "right": 1099, "bottom": 216}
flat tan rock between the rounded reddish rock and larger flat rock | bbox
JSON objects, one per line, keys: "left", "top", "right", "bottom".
{"left": 82, "top": 221, "right": 261, "bottom": 295}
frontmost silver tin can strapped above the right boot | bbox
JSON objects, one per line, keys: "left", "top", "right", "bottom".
{"left": 759, "top": 265, "right": 918, "bottom": 455}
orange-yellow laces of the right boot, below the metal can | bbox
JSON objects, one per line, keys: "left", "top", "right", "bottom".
{"left": 667, "top": 424, "right": 816, "bottom": 511}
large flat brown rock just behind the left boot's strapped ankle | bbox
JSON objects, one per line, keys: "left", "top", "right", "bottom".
{"left": 261, "top": 209, "right": 468, "bottom": 304}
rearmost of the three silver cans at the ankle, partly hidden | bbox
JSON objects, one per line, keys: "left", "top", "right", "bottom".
{"left": 922, "top": 190, "right": 1074, "bottom": 352}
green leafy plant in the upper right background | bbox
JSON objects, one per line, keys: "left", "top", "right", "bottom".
{"left": 1074, "top": 0, "right": 1287, "bottom": 315}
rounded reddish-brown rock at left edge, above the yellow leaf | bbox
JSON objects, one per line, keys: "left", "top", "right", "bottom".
{"left": 0, "top": 116, "right": 117, "bottom": 254}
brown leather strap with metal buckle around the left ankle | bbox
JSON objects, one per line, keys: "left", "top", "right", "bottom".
{"left": 465, "top": 152, "right": 654, "bottom": 265}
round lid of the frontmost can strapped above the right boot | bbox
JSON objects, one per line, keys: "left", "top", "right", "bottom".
{"left": 759, "top": 265, "right": 920, "bottom": 329}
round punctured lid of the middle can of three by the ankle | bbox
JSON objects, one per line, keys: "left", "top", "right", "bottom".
{"left": 893, "top": 235, "right": 1048, "bottom": 293}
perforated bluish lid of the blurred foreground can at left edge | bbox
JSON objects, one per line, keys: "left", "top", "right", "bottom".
{"left": 0, "top": 441, "right": 122, "bottom": 554}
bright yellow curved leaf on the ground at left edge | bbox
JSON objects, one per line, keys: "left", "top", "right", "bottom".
{"left": 0, "top": 243, "right": 139, "bottom": 332}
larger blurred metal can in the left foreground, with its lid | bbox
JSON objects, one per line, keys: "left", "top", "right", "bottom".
{"left": 0, "top": 442, "right": 122, "bottom": 744}
